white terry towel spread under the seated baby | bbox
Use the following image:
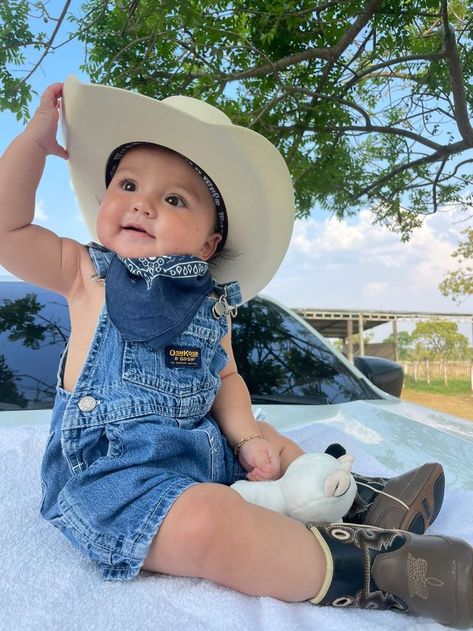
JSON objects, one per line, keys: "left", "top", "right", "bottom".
{"left": 0, "top": 426, "right": 473, "bottom": 631}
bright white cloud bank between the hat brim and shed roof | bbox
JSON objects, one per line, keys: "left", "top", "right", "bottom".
{"left": 265, "top": 210, "right": 473, "bottom": 313}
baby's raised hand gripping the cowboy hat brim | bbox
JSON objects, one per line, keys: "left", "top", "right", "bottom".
{"left": 25, "top": 83, "right": 69, "bottom": 160}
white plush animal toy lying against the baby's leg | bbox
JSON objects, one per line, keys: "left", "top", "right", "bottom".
{"left": 232, "top": 453, "right": 357, "bottom": 523}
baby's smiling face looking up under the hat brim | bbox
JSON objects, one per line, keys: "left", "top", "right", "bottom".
{"left": 97, "top": 146, "right": 221, "bottom": 260}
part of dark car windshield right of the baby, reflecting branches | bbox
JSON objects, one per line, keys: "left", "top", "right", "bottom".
{"left": 232, "top": 297, "right": 378, "bottom": 405}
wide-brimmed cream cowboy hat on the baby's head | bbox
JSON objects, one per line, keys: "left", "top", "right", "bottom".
{"left": 62, "top": 77, "right": 294, "bottom": 302}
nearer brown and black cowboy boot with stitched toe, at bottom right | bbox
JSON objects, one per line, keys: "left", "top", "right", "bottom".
{"left": 307, "top": 523, "right": 473, "bottom": 629}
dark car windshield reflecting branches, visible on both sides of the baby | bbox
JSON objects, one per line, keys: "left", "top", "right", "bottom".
{"left": 0, "top": 282, "right": 378, "bottom": 411}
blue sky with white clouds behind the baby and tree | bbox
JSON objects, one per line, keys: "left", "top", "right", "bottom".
{"left": 0, "top": 2, "right": 473, "bottom": 340}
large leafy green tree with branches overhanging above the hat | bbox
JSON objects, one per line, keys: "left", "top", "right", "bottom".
{"left": 0, "top": 0, "right": 473, "bottom": 238}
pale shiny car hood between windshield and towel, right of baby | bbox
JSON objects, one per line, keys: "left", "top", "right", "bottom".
{"left": 261, "top": 398, "right": 473, "bottom": 490}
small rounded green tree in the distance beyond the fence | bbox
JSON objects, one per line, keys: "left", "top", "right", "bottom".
{"left": 411, "top": 320, "right": 470, "bottom": 360}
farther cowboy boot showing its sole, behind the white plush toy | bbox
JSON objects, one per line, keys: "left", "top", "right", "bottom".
{"left": 343, "top": 463, "right": 445, "bottom": 534}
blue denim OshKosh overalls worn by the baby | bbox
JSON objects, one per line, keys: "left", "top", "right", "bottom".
{"left": 41, "top": 246, "right": 246, "bottom": 580}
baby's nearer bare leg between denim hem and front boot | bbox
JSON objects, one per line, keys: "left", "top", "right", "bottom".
{"left": 143, "top": 484, "right": 325, "bottom": 601}
